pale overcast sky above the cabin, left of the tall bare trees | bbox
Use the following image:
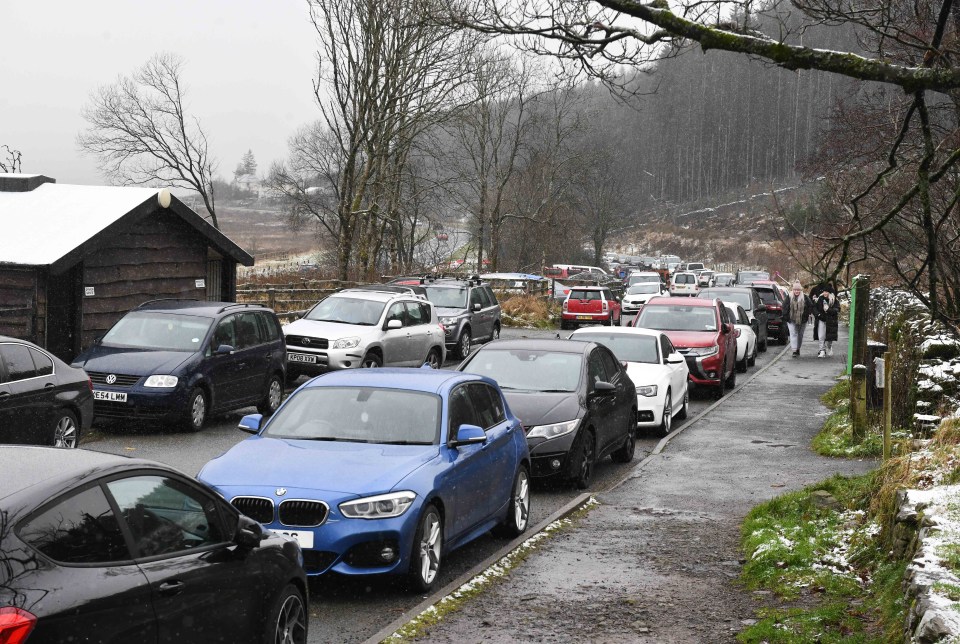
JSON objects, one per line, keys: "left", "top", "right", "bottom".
{"left": 0, "top": 0, "right": 319, "bottom": 184}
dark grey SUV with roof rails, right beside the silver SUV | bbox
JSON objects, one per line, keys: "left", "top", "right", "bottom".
{"left": 423, "top": 278, "right": 501, "bottom": 358}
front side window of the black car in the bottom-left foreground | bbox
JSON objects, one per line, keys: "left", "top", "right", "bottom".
{"left": 107, "top": 476, "right": 227, "bottom": 557}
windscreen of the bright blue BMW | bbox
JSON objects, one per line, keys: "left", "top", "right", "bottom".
{"left": 262, "top": 387, "right": 440, "bottom": 445}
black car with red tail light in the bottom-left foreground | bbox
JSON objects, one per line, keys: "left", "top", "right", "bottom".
{"left": 0, "top": 446, "right": 308, "bottom": 644}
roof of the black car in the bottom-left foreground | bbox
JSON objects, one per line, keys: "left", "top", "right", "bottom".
{"left": 0, "top": 445, "right": 170, "bottom": 499}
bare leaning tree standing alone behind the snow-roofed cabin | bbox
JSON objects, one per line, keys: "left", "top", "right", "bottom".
{"left": 77, "top": 53, "right": 219, "bottom": 228}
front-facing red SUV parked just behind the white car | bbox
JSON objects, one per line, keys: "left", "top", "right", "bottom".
{"left": 633, "top": 297, "right": 737, "bottom": 398}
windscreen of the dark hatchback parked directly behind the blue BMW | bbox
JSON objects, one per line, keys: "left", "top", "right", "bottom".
{"left": 463, "top": 349, "right": 583, "bottom": 392}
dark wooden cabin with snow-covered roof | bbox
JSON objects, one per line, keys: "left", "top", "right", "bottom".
{"left": 0, "top": 174, "right": 253, "bottom": 362}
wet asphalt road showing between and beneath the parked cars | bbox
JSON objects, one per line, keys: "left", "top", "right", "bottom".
{"left": 83, "top": 322, "right": 778, "bottom": 642}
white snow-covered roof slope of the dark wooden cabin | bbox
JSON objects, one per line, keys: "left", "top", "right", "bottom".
{"left": 0, "top": 180, "right": 160, "bottom": 266}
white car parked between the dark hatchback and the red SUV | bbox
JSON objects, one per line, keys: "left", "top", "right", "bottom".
{"left": 570, "top": 327, "right": 690, "bottom": 436}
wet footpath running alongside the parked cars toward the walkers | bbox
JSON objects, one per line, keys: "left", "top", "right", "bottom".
{"left": 404, "top": 329, "right": 875, "bottom": 644}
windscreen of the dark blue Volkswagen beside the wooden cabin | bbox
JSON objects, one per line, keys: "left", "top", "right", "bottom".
{"left": 101, "top": 311, "right": 213, "bottom": 351}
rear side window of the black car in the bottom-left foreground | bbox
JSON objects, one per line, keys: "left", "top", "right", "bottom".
{"left": 19, "top": 486, "right": 132, "bottom": 564}
